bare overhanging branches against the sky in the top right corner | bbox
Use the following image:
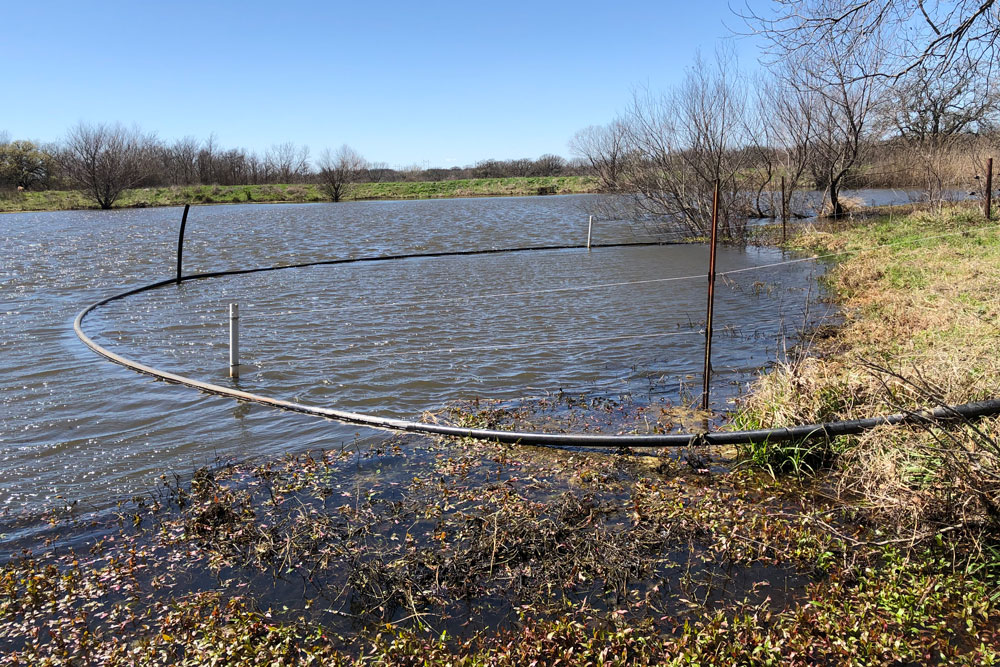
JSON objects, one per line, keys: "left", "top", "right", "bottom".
{"left": 741, "top": 0, "right": 1000, "bottom": 77}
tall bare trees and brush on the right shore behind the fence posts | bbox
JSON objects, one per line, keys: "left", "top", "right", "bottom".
{"left": 571, "top": 0, "right": 1000, "bottom": 238}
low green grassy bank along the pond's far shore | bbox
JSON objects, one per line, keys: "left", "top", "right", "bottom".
{"left": 0, "top": 176, "right": 598, "bottom": 212}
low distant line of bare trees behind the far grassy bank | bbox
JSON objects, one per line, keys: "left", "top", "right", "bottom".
{"left": 0, "top": 123, "right": 591, "bottom": 208}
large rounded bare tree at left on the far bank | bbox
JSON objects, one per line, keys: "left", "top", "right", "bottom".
{"left": 60, "top": 123, "right": 156, "bottom": 209}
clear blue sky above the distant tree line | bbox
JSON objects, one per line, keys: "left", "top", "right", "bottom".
{"left": 0, "top": 0, "right": 756, "bottom": 166}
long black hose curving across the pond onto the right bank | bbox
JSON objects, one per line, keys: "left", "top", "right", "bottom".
{"left": 73, "top": 242, "right": 1000, "bottom": 448}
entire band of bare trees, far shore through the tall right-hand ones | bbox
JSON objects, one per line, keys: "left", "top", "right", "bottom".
{"left": 7, "top": 0, "right": 1000, "bottom": 217}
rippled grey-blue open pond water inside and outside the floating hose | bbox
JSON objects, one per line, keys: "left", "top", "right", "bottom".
{"left": 0, "top": 196, "right": 825, "bottom": 538}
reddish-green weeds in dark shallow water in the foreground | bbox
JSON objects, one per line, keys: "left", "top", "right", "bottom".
{"left": 0, "top": 405, "right": 1000, "bottom": 665}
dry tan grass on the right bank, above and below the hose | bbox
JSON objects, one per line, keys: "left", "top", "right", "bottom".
{"left": 741, "top": 207, "right": 1000, "bottom": 537}
